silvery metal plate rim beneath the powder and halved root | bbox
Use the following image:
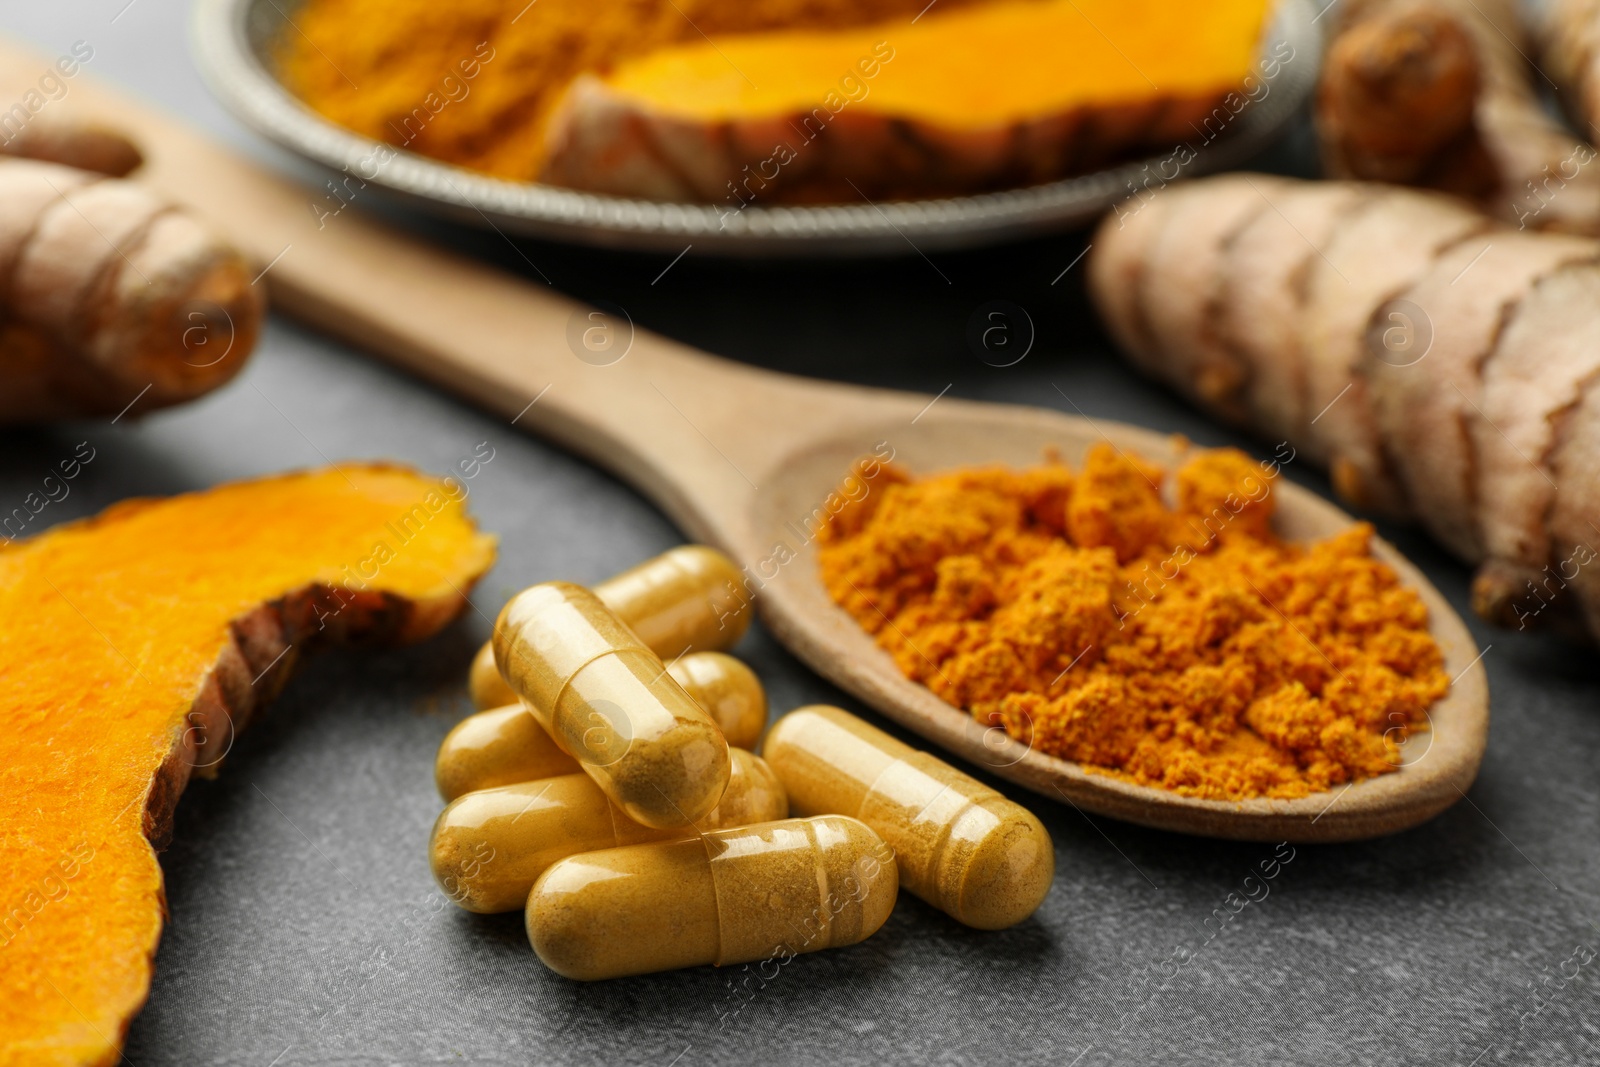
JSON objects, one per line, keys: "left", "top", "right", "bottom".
{"left": 195, "top": 0, "right": 1322, "bottom": 256}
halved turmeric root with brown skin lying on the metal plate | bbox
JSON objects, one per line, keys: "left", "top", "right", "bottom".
{"left": 542, "top": 0, "right": 1270, "bottom": 206}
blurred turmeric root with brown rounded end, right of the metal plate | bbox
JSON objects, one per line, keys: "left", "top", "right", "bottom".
{"left": 1317, "top": 0, "right": 1600, "bottom": 234}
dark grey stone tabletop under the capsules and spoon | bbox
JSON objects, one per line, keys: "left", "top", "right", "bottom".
{"left": 0, "top": 0, "right": 1600, "bottom": 1067}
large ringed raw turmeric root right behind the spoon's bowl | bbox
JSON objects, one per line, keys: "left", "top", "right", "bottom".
{"left": 1090, "top": 174, "right": 1600, "bottom": 640}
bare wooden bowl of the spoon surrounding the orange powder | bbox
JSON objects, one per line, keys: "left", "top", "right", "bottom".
{"left": 736, "top": 400, "right": 1488, "bottom": 841}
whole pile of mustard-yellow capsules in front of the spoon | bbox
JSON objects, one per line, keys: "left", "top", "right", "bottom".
{"left": 429, "top": 545, "right": 1056, "bottom": 981}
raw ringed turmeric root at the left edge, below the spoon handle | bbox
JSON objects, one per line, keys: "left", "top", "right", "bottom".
{"left": 0, "top": 123, "right": 264, "bottom": 424}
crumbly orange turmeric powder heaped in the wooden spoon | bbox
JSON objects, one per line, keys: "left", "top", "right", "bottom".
{"left": 819, "top": 445, "right": 1450, "bottom": 800}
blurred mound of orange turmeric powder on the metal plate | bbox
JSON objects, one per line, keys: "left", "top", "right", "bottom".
{"left": 275, "top": 0, "right": 982, "bottom": 181}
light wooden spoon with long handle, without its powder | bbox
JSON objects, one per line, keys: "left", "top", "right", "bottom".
{"left": 15, "top": 46, "right": 1488, "bottom": 841}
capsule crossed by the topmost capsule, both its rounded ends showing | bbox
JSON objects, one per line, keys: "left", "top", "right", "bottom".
{"left": 434, "top": 649, "right": 766, "bottom": 800}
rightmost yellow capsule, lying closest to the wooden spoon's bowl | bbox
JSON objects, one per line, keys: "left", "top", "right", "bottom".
{"left": 763, "top": 704, "right": 1056, "bottom": 929}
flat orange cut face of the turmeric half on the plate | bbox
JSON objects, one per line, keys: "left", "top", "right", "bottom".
{"left": 606, "top": 0, "right": 1267, "bottom": 128}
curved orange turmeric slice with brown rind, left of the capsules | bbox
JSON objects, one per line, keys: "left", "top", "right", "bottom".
{"left": 0, "top": 464, "right": 494, "bottom": 1067}
